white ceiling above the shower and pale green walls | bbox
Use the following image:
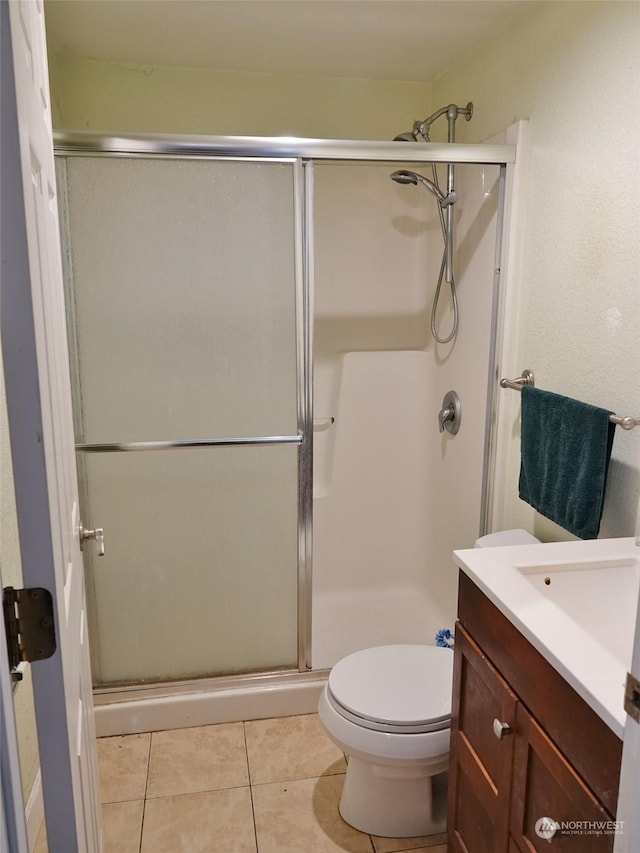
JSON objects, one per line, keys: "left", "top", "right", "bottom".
{"left": 45, "top": 0, "right": 536, "bottom": 82}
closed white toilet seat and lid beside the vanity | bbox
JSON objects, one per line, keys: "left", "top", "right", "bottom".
{"left": 327, "top": 645, "right": 453, "bottom": 734}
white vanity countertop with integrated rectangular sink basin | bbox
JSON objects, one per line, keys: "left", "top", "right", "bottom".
{"left": 454, "top": 537, "right": 640, "bottom": 737}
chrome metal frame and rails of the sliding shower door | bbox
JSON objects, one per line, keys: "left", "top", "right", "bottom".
{"left": 54, "top": 131, "right": 515, "bottom": 704}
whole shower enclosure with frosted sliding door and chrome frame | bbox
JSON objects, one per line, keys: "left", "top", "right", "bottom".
{"left": 56, "top": 133, "right": 514, "bottom": 720}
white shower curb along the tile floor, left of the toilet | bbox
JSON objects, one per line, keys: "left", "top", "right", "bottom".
{"left": 95, "top": 678, "right": 325, "bottom": 737}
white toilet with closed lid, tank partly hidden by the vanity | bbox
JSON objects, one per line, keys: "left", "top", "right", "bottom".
{"left": 318, "top": 530, "right": 539, "bottom": 838}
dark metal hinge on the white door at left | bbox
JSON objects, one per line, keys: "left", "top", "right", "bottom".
{"left": 2, "top": 586, "right": 56, "bottom": 681}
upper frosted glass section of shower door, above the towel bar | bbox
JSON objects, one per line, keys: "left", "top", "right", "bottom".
{"left": 62, "top": 156, "right": 297, "bottom": 443}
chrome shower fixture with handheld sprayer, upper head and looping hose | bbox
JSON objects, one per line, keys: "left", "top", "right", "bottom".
{"left": 391, "top": 101, "right": 473, "bottom": 344}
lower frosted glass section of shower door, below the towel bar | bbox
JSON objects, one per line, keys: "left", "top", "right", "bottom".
{"left": 85, "top": 445, "right": 298, "bottom": 686}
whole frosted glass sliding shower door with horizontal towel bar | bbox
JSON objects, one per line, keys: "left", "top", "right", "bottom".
{"left": 58, "top": 155, "right": 304, "bottom": 686}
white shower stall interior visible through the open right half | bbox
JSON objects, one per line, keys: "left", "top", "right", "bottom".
{"left": 312, "top": 158, "right": 498, "bottom": 669}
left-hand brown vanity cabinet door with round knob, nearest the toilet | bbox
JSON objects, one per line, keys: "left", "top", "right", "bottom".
{"left": 447, "top": 623, "right": 517, "bottom": 853}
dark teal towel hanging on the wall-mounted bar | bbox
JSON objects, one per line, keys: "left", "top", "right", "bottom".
{"left": 519, "top": 385, "right": 615, "bottom": 539}
